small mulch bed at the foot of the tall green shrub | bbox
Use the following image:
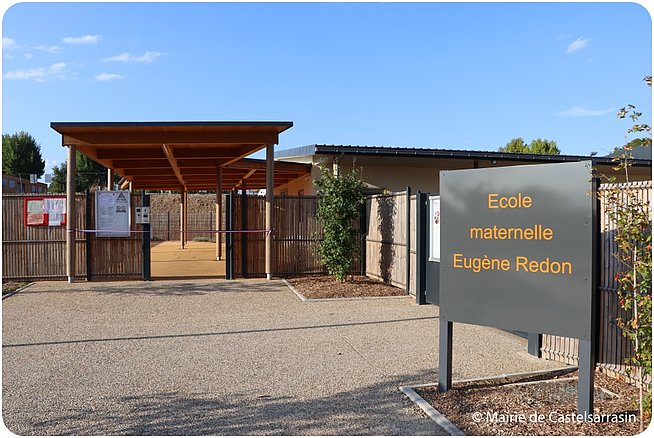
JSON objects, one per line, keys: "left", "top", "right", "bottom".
{"left": 288, "top": 275, "right": 407, "bottom": 299}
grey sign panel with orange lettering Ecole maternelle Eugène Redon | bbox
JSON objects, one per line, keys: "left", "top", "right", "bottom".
{"left": 440, "top": 162, "right": 594, "bottom": 340}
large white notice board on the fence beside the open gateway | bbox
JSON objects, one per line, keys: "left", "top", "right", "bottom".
{"left": 95, "top": 190, "right": 131, "bottom": 237}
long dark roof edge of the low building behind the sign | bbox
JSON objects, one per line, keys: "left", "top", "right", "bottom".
{"left": 275, "top": 144, "right": 652, "bottom": 167}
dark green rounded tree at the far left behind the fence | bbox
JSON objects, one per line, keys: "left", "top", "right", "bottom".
{"left": 2, "top": 131, "right": 45, "bottom": 178}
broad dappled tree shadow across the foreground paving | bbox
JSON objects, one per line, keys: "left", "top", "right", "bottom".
{"left": 5, "top": 372, "right": 444, "bottom": 435}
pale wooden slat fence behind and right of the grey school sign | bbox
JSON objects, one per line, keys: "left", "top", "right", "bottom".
{"left": 541, "top": 181, "right": 652, "bottom": 381}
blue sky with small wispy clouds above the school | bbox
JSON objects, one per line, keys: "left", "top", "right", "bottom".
{"left": 2, "top": 3, "right": 652, "bottom": 176}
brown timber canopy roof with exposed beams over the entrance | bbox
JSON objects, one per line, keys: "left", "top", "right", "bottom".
{"left": 50, "top": 122, "right": 310, "bottom": 190}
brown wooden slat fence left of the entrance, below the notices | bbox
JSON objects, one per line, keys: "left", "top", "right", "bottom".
{"left": 2, "top": 193, "right": 142, "bottom": 281}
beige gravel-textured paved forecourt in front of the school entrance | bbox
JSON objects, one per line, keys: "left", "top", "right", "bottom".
{"left": 2, "top": 280, "right": 559, "bottom": 435}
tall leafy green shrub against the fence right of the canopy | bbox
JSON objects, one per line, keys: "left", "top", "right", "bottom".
{"left": 314, "top": 166, "right": 366, "bottom": 282}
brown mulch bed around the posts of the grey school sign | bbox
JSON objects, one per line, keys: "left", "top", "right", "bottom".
{"left": 415, "top": 372, "right": 649, "bottom": 435}
